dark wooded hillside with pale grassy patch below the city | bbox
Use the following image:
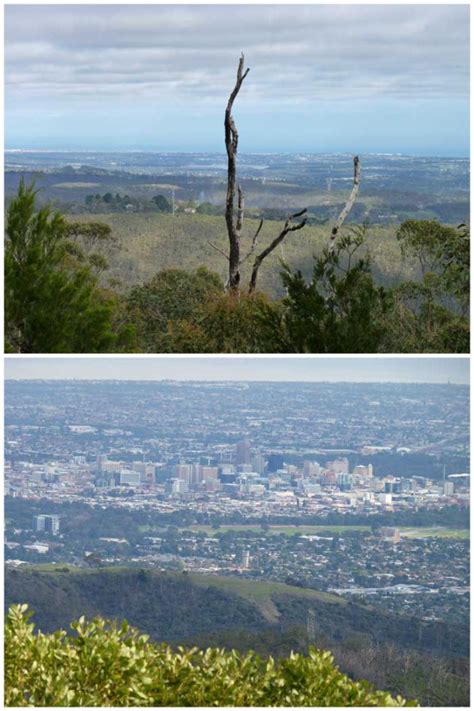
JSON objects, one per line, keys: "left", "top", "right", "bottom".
{"left": 5, "top": 566, "right": 469, "bottom": 656}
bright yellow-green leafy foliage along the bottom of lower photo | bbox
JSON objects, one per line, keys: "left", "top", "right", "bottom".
{"left": 5, "top": 605, "right": 414, "bottom": 707}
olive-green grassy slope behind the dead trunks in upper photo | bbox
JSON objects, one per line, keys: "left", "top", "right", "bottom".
{"left": 71, "top": 213, "right": 416, "bottom": 296}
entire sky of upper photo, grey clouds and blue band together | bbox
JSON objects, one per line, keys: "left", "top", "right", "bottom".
{"left": 5, "top": 5, "right": 469, "bottom": 156}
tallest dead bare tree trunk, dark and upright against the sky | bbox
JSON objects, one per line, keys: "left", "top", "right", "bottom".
{"left": 224, "top": 54, "right": 250, "bottom": 290}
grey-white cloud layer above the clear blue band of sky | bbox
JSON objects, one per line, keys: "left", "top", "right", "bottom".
{"left": 6, "top": 5, "right": 469, "bottom": 106}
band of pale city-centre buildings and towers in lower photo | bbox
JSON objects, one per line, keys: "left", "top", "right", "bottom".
{"left": 5, "top": 440, "right": 469, "bottom": 520}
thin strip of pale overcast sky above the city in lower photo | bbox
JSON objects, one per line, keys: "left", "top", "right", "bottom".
{"left": 5, "top": 356, "right": 469, "bottom": 384}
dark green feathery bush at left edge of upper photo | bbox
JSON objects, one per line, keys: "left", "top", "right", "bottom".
{"left": 5, "top": 181, "right": 124, "bottom": 353}
